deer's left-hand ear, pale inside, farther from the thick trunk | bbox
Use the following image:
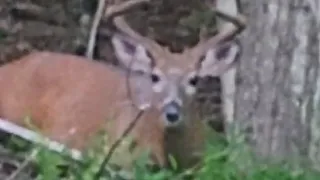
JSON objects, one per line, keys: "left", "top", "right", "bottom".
{"left": 111, "top": 34, "right": 152, "bottom": 72}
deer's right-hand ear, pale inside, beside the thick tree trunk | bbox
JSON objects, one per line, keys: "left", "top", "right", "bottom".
{"left": 199, "top": 41, "right": 240, "bottom": 77}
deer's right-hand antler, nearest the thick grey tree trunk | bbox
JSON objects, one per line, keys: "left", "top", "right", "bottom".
{"left": 193, "top": 10, "right": 247, "bottom": 55}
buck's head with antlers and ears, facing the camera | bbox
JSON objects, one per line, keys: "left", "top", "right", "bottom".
{"left": 106, "top": 0, "right": 245, "bottom": 127}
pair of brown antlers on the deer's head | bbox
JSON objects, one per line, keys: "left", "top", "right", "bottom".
{"left": 100, "top": 0, "right": 246, "bottom": 63}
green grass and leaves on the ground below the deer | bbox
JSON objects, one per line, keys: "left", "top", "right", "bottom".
{"left": 1, "top": 128, "right": 320, "bottom": 180}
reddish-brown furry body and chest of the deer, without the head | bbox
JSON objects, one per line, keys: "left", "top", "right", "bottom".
{"left": 0, "top": 52, "right": 208, "bottom": 169}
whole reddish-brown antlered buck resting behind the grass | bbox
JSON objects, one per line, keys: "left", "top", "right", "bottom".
{"left": 0, "top": 0, "right": 244, "bottom": 171}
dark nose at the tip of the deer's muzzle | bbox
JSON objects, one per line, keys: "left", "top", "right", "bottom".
{"left": 164, "top": 102, "right": 180, "bottom": 124}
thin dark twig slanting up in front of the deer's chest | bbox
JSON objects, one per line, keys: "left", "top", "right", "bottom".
{"left": 93, "top": 110, "right": 144, "bottom": 180}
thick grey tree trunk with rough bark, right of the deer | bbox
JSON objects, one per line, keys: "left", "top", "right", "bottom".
{"left": 234, "top": 0, "right": 320, "bottom": 166}
